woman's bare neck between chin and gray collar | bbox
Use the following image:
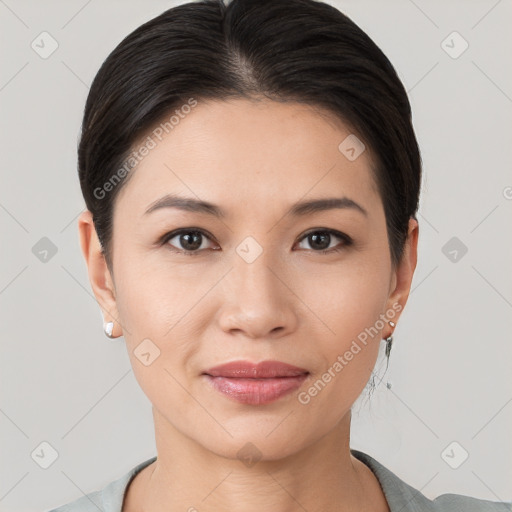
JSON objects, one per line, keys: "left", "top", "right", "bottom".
{"left": 127, "top": 408, "right": 389, "bottom": 512}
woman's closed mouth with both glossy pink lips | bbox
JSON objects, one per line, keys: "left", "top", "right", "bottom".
{"left": 202, "top": 361, "right": 309, "bottom": 405}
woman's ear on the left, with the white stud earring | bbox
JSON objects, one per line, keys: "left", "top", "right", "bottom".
{"left": 78, "top": 210, "right": 122, "bottom": 337}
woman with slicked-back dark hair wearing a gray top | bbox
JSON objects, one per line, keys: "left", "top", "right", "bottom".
{"left": 48, "top": 0, "right": 511, "bottom": 512}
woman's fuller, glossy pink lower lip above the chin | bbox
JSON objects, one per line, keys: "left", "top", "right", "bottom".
{"left": 205, "top": 374, "right": 308, "bottom": 405}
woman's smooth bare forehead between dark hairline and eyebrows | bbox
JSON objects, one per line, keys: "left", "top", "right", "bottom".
{"left": 116, "top": 99, "right": 377, "bottom": 219}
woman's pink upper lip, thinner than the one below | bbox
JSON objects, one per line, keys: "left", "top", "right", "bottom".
{"left": 204, "top": 361, "right": 309, "bottom": 379}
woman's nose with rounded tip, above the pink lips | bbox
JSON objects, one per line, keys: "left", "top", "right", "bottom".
{"left": 218, "top": 251, "right": 300, "bottom": 339}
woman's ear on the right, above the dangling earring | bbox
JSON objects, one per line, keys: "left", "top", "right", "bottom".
{"left": 386, "top": 219, "right": 419, "bottom": 337}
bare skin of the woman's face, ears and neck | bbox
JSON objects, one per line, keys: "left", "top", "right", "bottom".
{"left": 79, "top": 99, "right": 418, "bottom": 512}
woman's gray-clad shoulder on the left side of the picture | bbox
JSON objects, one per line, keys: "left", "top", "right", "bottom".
{"left": 48, "top": 456, "right": 156, "bottom": 512}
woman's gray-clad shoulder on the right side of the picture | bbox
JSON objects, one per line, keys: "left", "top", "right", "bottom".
{"left": 350, "top": 449, "right": 512, "bottom": 512}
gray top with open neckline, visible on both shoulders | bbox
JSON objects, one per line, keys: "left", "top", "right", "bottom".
{"left": 48, "top": 450, "right": 512, "bottom": 512}
